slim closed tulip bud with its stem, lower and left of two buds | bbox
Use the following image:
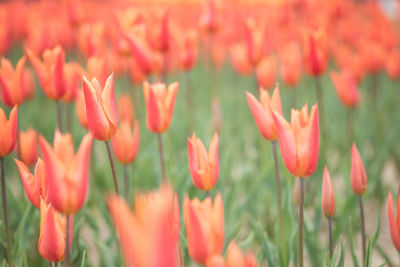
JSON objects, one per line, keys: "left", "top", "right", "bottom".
{"left": 321, "top": 168, "right": 336, "bottom": 259}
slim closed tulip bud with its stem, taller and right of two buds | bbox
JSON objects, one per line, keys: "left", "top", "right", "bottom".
{"left": 350, "top": 143, "right": 367, "bottom": 263}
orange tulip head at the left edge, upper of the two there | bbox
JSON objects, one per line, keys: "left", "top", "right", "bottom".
{"left": 0, "top": 57, "right": 28, "bottom": 107}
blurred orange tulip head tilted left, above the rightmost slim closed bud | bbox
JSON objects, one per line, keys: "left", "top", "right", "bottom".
{"left": 331, "top": 69, "right": 361, "bottom": 108}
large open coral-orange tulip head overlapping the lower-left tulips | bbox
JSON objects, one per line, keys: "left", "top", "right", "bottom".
{"left": 39, "top": 130, "right": 93, "bottom": 215}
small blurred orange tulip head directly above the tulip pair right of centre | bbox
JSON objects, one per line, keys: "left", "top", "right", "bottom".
{"left": 256, "top": 56, "right": 277, "bottom": 88}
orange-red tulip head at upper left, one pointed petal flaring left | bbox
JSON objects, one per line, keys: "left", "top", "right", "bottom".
{"left": 27, "top": 46, "right": 66, "bottom": 100}
